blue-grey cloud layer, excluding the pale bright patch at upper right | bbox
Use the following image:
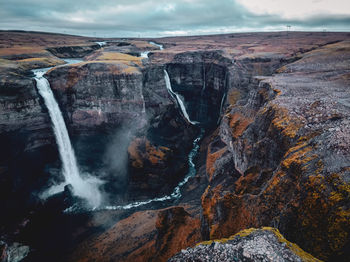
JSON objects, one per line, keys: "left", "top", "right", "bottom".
{"left": 0, "top": 0, "right": 350, "bottom": 36}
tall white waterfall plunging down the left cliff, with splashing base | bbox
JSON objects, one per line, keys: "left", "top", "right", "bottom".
{"left": 33, "top": 68, "right": 102, "bottom": 207}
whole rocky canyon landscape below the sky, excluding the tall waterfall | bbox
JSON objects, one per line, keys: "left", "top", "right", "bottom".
{"left": 0, "top": 31, "right": 350, "bottom": 262}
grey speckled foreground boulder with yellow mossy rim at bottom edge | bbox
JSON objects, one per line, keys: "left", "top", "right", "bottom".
{"left": 168, "top": 228, "right": 320, "bottom": 262}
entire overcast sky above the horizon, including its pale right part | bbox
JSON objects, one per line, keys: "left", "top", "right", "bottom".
{"left": 0, "top": 0, "right": 350, "bottom": 37}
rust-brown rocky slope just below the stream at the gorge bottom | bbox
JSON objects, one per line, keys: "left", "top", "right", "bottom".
{"left": 68, "top": 207, "right": 200, "bottom": 262}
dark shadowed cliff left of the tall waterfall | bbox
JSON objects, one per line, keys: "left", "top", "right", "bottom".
{"left": 0, "top": 59, "right": 62, "bottom": 229}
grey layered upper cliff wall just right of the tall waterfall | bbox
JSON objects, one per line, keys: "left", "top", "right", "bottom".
{"left": 48, "top": 61, "right": 144, "bottom": 133}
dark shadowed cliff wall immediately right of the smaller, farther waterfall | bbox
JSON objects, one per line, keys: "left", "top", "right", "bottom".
{"left": 166, "top": 51, "right": 231, "bottom": 128}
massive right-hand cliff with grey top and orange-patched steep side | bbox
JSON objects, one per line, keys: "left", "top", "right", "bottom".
{"left": 202, "top": 41, "right": 350, "bottom": 259}
